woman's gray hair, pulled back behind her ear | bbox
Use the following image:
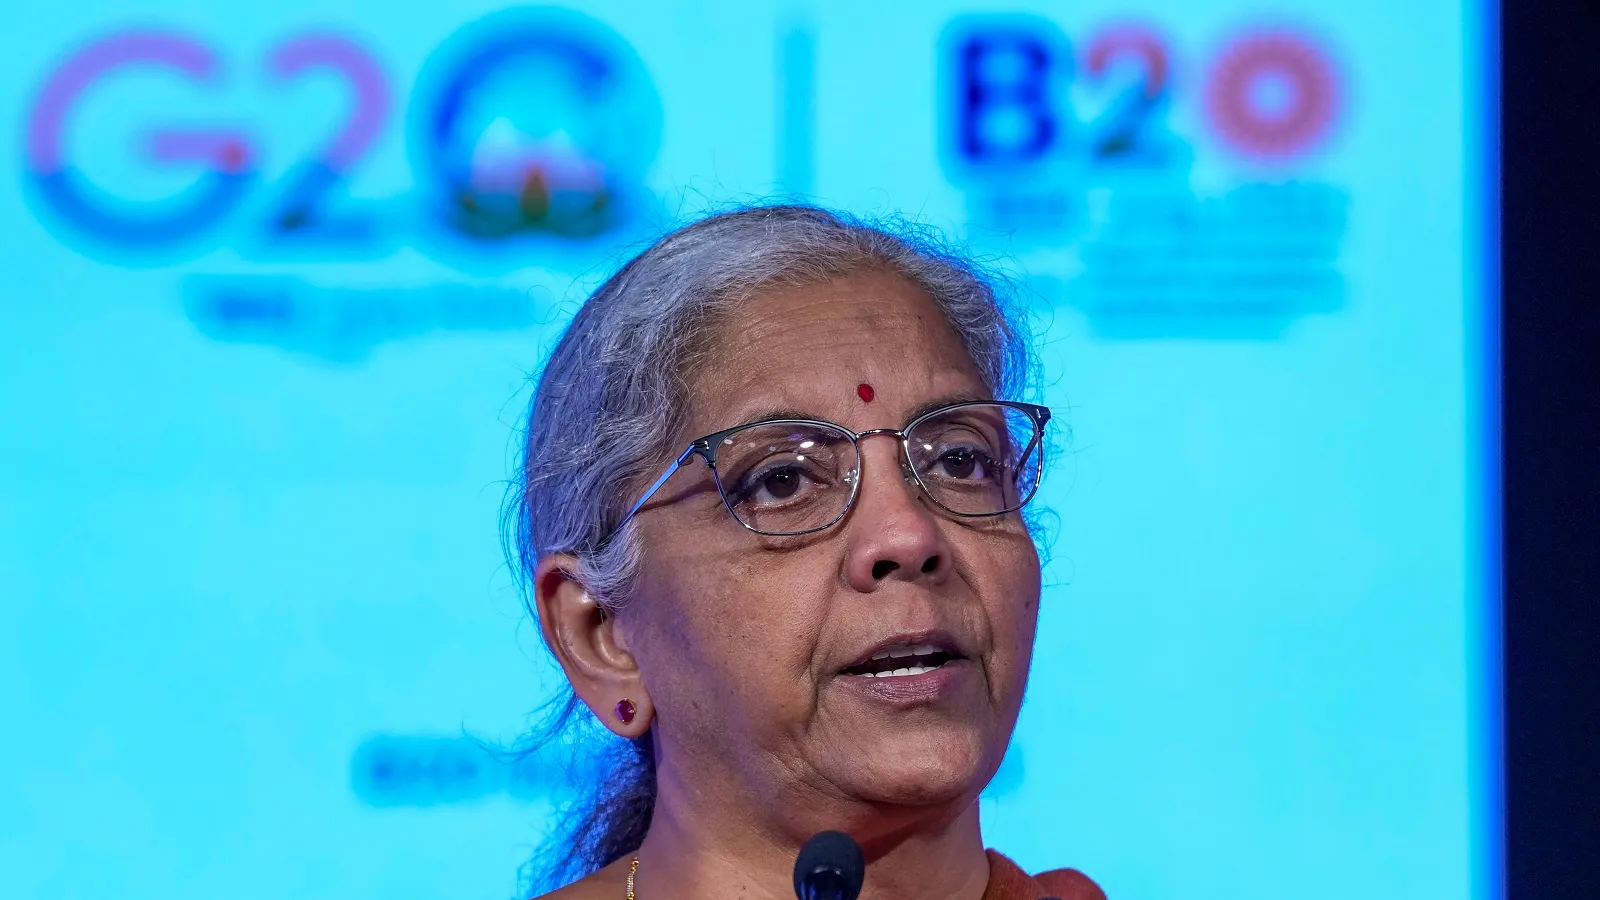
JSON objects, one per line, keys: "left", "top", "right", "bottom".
{"left": 507, "top": 205, "right": 1032, "bottom": 887}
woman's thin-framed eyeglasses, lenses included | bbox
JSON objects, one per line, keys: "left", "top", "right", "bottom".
{"left": 606, "top": 400, "right": 1050, "bottom": 541}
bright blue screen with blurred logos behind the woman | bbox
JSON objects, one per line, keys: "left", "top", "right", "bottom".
{"left": 0, "top": 0, "right": 1501, "bottom": 900}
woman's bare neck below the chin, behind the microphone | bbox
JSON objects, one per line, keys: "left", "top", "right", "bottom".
{"left": 635, "top": 752, "right": 989, "bottom": 900}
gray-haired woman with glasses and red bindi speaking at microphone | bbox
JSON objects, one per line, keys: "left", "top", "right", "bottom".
{"left": 517, "top": 207, "right": 1102, "bottom": 900}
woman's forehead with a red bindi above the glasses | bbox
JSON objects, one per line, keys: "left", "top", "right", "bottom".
{"left": 688, "top": 272, "right": 987, "bottom": 434}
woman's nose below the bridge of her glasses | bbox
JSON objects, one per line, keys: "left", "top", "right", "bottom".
{"left": 845, "top": 436, "right": 950, "bottom": 593}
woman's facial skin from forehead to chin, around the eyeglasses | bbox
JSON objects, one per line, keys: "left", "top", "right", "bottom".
{"left": 616, "top": 274, "right": 1040, "bottom": 831}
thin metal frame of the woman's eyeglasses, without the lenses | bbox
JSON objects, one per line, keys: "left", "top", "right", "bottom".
{"left": 600, "top": 400, "right": 1050, "bottom": 546}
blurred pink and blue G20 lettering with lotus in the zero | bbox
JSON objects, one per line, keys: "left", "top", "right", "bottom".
{"left": 26, "top": 10, "right": 661, "bottom": 262}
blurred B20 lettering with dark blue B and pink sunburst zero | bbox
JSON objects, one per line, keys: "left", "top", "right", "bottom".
{"left": 942, "top": 16, "right": 1341, "bottom": 173}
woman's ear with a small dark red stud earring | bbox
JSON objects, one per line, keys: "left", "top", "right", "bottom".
{"left": 533, "top": 552, "right": 654, "bottom": 738}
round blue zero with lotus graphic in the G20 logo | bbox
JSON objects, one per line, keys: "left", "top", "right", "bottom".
{"left": 410, "top": 10, "right": 661, "bottom": 245}
